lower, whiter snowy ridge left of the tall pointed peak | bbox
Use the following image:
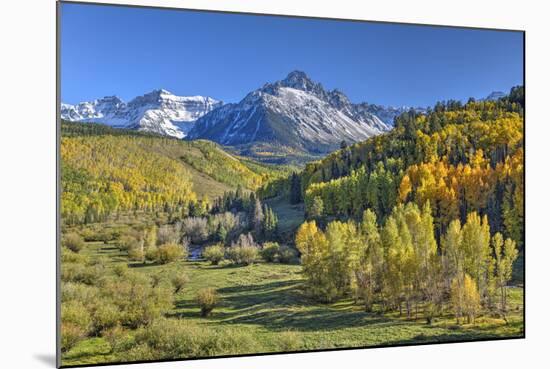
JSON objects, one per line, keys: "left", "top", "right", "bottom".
{"left": 61, "top": 89, "right": 223, "bottom": 138}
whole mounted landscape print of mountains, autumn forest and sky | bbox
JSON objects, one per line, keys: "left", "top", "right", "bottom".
{"left": 57, "top": 2, "right": 525, "bottom": 367}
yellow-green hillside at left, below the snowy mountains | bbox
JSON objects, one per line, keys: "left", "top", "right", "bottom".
{"left": 61, "top": 122, "right": 289, "bottom": 221}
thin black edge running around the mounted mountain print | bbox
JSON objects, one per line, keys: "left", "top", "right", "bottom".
{"left": 55, "top": 0, "right": 527, "bottom": 368}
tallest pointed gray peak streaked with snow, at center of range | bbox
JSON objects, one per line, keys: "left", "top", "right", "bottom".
{"left": 188, "top": 71, "right": 391, "bottom": 153}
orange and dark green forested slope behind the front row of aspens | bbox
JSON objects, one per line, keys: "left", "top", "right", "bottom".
{"left": 270, "top": 87, "right": 524, "bottom": 245}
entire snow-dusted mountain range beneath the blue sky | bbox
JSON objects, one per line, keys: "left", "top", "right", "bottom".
{"left": 61, "top": 71, "right": 432, "bottom": 147}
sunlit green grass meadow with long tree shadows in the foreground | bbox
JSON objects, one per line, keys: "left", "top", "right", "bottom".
{"left": 62, "top": 242, "right": 523, "bottom": 366}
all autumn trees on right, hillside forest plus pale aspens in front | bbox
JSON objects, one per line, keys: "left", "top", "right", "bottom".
{"left": 274, "top": 87, "right": 524, "bottom": 322}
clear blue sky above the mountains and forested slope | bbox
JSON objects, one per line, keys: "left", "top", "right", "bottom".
{"left": 61, "top": 3, "right": 523, "bottom": 106}
